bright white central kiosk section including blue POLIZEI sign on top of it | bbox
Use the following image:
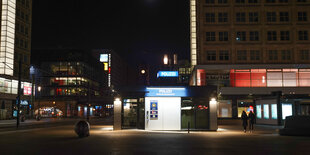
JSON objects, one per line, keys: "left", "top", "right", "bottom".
{"left": 145, "top": 87, "right": 187, "bottom": 130}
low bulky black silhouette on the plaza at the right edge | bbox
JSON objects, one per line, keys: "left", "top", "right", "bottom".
{"left": 279, "top": 116, "right": 310, "bottom": 136}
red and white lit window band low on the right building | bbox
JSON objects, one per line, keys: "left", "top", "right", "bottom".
{"left": 197, "top": 69, "right": 310, "bottom": 87}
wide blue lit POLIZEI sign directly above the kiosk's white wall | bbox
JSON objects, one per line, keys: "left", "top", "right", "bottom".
{"left": 145, "top": 87, "right": 187, "bottom": 97}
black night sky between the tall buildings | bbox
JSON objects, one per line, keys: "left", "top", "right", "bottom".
{"left": 32, "top": 0, "right": 189, "bottom": 65}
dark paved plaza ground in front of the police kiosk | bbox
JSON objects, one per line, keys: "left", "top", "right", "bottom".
{"left": 0, "top": 121, "right": 310, "bottom": 155}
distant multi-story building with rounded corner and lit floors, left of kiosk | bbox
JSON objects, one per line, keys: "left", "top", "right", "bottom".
{"left": 32, "top": 49, "right": 112, "bottom": 117}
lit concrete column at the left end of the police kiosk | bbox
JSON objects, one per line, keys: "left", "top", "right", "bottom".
{"left": 113, "top": 98, "right": 122, "bottom": 130}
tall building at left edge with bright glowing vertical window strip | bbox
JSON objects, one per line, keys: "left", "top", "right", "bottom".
{"left": 0, "top": 0, "right": 32, "bottom": 119}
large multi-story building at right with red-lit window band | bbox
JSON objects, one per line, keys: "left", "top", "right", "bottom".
{"left": 190, "top": 0, "right": 310, "bottom": 123}
